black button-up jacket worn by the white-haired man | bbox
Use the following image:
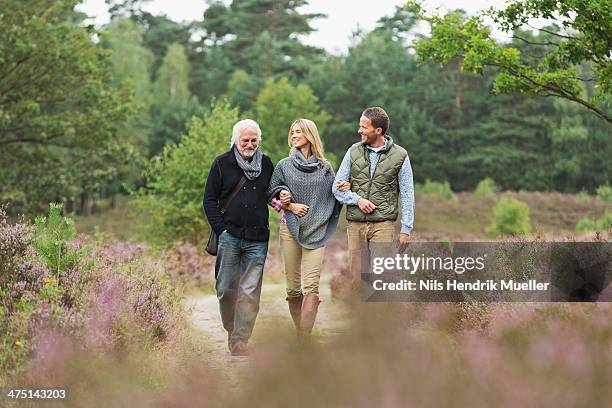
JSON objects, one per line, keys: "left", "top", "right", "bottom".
{"left": 204, "top": 148, "right": 274, "bottom": 241}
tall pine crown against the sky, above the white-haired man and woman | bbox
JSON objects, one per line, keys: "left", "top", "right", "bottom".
{"left": 192, "top": 0, "right": 323, "bottom": 100}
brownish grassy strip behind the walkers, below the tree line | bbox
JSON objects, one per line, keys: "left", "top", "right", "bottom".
{"left": 75, "top": 192, "right": 606, "bottom": 244}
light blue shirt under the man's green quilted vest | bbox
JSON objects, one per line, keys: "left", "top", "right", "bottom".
{"left": 332, "top": 140, "right": 414, "bottom": 234}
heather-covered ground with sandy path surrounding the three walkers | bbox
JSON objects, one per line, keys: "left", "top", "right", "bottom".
{"left": 0, "top": 193, "right": 612, "bottom": 407}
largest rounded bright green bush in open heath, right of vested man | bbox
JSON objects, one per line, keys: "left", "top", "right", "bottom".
{"left": 487, "top": 198, "right": 531, "bottom": 236}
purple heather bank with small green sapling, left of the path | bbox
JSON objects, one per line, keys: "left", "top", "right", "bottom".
{"left": 0, "top": 209, "right": 186, "bottom": 376}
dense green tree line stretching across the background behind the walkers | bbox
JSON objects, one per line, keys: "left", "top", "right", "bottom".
{"left": 0, "top": 0, "right": 612, "bottom": 214}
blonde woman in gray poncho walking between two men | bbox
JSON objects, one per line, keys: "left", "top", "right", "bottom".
{"left": 268, "top": 119, "right": 341, "bottom": 338}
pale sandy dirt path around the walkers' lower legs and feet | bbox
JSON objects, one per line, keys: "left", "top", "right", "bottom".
{"left": 186, "top": 272, "right": 349, "bottom": 382}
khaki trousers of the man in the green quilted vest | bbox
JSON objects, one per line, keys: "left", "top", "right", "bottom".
{"left": 346, "top": 221, "right": 396, "bottom": 288}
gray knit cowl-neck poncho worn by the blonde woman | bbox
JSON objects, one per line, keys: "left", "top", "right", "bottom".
{"left": 268, "top": 150, "right": 341, "bottom": 249}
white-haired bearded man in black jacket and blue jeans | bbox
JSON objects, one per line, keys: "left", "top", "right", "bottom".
{"left": 204, "top": 119, "right": 274, "bottom": 355}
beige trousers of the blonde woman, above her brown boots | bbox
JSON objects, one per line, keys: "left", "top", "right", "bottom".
{"left": 279, "top": 224, "right": 325, "bottom": 297}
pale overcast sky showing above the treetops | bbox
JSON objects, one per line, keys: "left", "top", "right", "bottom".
{"left": 78, "top": 0, "right": 516, "bottom": 53}
